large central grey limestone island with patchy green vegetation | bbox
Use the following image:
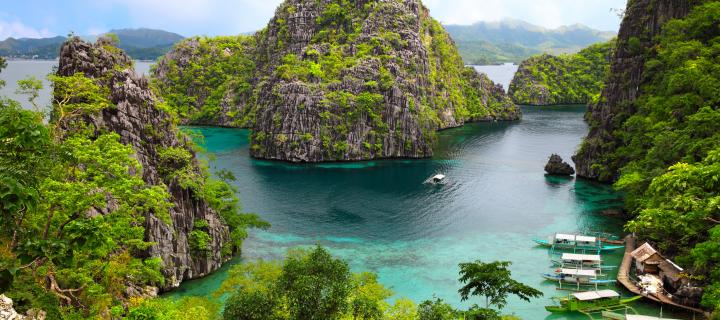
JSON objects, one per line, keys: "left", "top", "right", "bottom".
{"left": 155, "top": 0, "right": 520, "bottom": 162}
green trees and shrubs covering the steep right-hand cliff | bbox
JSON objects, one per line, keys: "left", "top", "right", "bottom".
{"left": 609, "top": 1, "right": 720, "bottom": 309}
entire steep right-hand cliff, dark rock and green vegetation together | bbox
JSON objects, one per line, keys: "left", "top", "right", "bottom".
{"left": 575, "top": 1, "right": 720, "bottom": 317}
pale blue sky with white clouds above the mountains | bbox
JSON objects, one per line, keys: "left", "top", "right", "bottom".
{"left": 0, "top": 0, "right": 626, "bottom": 39}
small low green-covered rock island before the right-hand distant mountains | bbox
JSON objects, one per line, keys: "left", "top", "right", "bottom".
{"left": 509, "top": 41, "right": 615, "bottom": 105}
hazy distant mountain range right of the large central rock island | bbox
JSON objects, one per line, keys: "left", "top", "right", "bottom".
{"left": 445, "top": 19, "right": 616, "bottom": 64}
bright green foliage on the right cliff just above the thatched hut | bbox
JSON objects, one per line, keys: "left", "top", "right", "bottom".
{"left": 621, "top": 148, "right": 720, "bottom": 309}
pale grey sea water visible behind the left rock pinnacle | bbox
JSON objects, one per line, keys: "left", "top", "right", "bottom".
{"left": 0, "top": 60, "right": 153, "bottom": 109}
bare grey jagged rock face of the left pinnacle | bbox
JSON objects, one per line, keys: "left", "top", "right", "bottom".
{"left": 57, "top": 37, "right": 229, "bottom": 289}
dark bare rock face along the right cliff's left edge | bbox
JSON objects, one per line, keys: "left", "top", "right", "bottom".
{"left": 573, "top": 0, "right": 692, "bottom": 182}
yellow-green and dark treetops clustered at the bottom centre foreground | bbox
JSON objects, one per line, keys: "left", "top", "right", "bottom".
{"left": 222, "top": 247, "right": 417, "bottom": 320}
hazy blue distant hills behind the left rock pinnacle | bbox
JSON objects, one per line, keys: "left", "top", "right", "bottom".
{"left": 0, "top": 28, "right": 184, "bottom": 60}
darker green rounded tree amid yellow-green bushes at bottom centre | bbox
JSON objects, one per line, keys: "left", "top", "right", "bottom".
{"left": 279, "top": 246, "right": 352, "bottom": 320}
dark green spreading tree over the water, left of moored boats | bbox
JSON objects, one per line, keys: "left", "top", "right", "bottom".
{"left": 459, "top": 260, "right": 543, "bottom": 309}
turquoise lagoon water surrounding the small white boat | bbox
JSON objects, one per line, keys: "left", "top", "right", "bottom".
{"left": 170, "top": 106, "right": 696, "bottom": 319}
